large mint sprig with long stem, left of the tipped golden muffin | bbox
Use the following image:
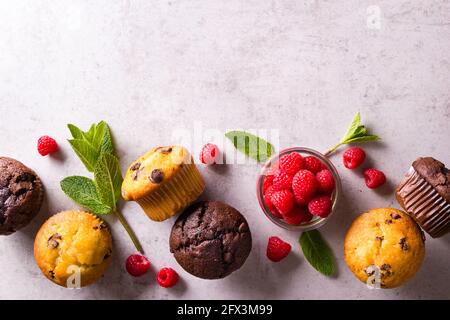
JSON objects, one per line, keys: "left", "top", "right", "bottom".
{"left": 61, "top": 121, "right": 144, "bottom": 254}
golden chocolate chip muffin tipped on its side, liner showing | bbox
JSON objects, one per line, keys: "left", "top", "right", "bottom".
{"left": 122, "top": 146, "right": 205, "bottom": 221}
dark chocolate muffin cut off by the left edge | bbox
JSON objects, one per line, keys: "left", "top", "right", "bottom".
{"left": 0, "top": 157, "right": 44, "bottom": 235}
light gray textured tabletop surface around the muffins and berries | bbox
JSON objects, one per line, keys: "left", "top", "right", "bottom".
{"left": 0, "top": 0, "right": 450, "bottom": 299}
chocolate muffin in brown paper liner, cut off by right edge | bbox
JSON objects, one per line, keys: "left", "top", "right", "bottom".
{"left": 396, "top": 157, "right": 450, "bottom": 238}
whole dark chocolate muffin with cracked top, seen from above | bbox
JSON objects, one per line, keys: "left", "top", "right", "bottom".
{"left": 170, "top": 201, "right": 252, "bottom": 279}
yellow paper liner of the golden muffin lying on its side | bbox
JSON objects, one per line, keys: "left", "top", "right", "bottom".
{"left": 137, "top": 161, "right": 205, "bottom": 221}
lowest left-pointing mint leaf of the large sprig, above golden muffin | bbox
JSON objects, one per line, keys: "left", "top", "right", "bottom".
{"left": 60, "top": 176, "right": 111, "bottom": 214}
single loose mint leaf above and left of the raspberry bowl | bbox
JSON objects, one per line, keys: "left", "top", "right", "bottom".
{"left": 225, "top": 131, "right": 275, "bottom": 162}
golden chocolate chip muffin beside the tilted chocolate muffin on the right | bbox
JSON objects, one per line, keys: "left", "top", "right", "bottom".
{"left": 344, "top": 208, "right": 425, "bottom": 288}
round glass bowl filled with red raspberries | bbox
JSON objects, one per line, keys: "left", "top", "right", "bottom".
{"left": 256, "top": 147, "right": 341, "bottom": 231}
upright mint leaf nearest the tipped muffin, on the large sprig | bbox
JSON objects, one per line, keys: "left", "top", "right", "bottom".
{"left": 94, "top": 153, "right": 123, "bottom": 210}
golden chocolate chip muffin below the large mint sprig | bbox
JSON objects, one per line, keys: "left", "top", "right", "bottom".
{"left": 34, "top": 211, "right": 112, "bottom": 288}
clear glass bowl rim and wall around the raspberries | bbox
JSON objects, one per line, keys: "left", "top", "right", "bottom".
{"left": 256, "top": 147, "right": 342, "bottom": 231}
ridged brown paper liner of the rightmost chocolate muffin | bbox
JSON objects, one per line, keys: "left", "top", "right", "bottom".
{"left": 397, "top": 168, "right": 450, "bottom": 238}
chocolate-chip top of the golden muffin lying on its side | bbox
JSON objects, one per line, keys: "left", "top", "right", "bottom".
{"left": 122, "top": 146, "right": 193, "bottom": 201}
